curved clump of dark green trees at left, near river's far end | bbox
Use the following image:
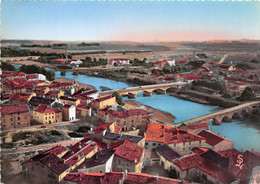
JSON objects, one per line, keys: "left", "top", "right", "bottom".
{"left": 20, "top": 65, "right": 55, "bottom": 81}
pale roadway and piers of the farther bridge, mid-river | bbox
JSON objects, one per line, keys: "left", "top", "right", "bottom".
{"left": 99, "top": 82, "right": 188, "bottom": 97}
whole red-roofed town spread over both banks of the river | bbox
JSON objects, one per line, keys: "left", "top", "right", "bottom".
{"left": 1, "top": 45, "right": 260, "bottom": 184}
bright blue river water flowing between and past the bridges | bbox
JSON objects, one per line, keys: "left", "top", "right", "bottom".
{"left": 55, "top": 72, "right": 260, "bottom": 152}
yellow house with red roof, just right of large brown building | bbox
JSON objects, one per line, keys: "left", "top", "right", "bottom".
{"left": 32, "top": 106, "right": 62, "bottom": 124}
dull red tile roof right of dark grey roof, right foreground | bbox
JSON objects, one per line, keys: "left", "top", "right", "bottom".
{"left": 174, "top": 154, "right": 204, "bottom": 171}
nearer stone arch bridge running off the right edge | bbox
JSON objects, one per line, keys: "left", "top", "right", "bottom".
{"left": 180, "top": 101, "right": 260, "bottom": 126}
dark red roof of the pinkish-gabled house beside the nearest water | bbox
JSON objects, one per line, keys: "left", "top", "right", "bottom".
{"left": 198, "top": 130, "right": 231, "bottom": 146}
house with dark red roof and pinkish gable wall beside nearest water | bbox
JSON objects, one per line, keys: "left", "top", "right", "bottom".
{"left": 198, "top": 130, "right": 234, "bottom": 152}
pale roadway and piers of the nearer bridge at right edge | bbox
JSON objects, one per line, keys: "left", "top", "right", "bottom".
{"left": 179, "top": 101, "right": 260, "bottom": 126}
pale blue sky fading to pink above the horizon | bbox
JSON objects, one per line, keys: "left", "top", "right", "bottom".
{"left": 1, "top": 0, "right": 260, "bottom": 42}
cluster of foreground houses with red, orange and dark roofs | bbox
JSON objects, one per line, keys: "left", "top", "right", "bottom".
{"left": 22, "top": 119, "right": 260, "bottom": 184}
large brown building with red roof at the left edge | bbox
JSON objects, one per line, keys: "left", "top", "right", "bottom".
{"left": 1, "top": 105, "right": 30, "bottom": 129}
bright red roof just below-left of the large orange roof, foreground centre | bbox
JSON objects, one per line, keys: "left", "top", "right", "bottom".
{"left": 110, "top": 140, "right": 144, "bottom": 163}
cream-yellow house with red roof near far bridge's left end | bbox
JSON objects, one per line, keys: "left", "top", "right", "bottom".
{"left": 91, "top": 96, "right": 116, "bottom": 109}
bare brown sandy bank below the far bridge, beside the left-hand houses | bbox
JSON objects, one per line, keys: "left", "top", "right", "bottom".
{"left": 124, "top": 101, "right": 176, "bottom": 124}
